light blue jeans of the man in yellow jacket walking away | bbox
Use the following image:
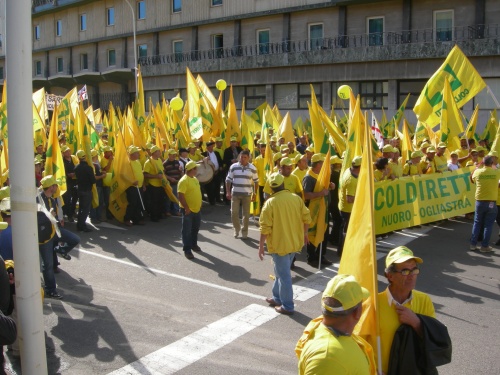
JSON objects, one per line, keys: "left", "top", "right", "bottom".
{"left": 270, "top": 253, "right": 295, "bottom": 311}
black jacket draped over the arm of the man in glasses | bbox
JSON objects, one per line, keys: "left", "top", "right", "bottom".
{"left": 386, "top": 314, "right": 452, "bottom": 375}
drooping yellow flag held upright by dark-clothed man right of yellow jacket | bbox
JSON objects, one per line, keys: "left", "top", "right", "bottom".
{"left": 308, "top": 150, "right": 331, "bottom": 246}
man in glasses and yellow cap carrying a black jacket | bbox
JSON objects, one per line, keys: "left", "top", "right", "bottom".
{"left": 378, "top": 246, "right": 436, "bottom": 373}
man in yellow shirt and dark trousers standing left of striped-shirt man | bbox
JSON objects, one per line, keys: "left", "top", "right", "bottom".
{"left": 177, "top": 160, "right": 201, "bottom": 259}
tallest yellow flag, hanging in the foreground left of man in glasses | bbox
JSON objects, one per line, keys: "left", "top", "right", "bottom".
{"left": 339, "top": 110, "right": 380, "bottom": 352}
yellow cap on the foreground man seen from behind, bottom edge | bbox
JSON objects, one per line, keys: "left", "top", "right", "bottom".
{"left": 321, "top": 274, "right": 370, "bottom": 312}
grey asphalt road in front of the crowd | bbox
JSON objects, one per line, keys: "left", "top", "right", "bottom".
{"left": 6, "top": 205, "right": 500, "bottom": 375}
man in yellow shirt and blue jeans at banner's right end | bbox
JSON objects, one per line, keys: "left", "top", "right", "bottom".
{"left": 470, "top": 155, "right": 500, "bottom": 253}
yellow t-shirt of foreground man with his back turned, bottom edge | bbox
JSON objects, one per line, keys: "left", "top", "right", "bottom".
{"left": 295, "top": 317, "right": 376, "bottom": 375}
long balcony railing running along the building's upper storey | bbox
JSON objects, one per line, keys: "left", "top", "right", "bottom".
{"left": 139, "top": 24, "right": 500, "bottom": 66}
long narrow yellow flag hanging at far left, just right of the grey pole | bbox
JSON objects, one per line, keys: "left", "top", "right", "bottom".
{"left": 44, "top": 104, "right": 67, "bottom": 195}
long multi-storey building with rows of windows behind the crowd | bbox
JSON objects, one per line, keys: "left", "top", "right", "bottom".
{"left": 0, "top": 0, "right": 500, "bottom": 126}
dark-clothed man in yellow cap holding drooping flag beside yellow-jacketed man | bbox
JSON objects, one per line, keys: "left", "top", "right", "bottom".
{"left": 302, "top": 154, "right": 335, "bottom": 268}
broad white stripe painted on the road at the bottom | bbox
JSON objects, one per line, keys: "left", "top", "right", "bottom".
{"left": 109, "top": 304, "right": 279, "bottom": 375}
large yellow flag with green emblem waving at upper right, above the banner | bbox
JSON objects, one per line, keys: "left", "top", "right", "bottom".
{"left": 413, "top": 46, "right": 486, "bottom": 128}
